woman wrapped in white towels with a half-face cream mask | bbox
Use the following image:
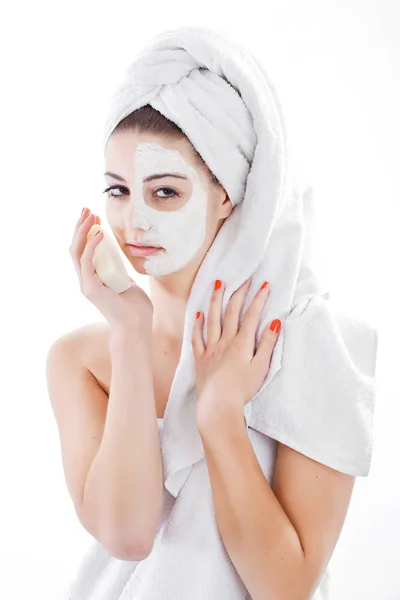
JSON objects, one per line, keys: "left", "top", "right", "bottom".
{"left": 45, "top": 28, "right": 376, "bottom": 600}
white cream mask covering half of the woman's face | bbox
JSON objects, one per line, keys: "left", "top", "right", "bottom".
{"left": 133, "top": 143, "right": 207, "bottom": 276}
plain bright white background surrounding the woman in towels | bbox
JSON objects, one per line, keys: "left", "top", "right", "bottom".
{"left": 0, "top": 0, "right": 400, "bottom": 600}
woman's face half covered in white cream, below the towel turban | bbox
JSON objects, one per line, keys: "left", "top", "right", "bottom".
{"left": 105, "top": 131, "right": 230, "bottom": 276}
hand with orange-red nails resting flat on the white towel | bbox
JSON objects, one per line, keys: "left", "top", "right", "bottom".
{"left": 192, "top": 278, "right": 281, "bottom": 426}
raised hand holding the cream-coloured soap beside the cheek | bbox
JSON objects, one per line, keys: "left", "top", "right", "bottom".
{"left": 69, "top": 208, "right": 153, "bottom": 332}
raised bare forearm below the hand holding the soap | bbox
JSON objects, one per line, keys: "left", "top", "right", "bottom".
{"left": 83, "top": 327, "right": 163, "bottom": 560}
